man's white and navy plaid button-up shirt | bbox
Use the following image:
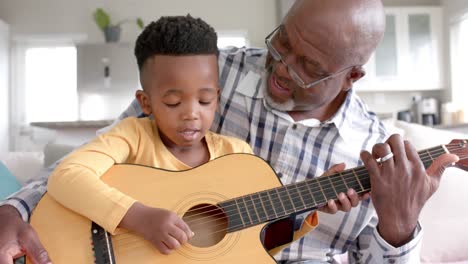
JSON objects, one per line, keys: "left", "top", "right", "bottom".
{"left": 1, "top": 49, "right": 422, "bottom": 263}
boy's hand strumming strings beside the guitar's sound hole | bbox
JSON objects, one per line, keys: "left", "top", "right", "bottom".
{"left": 119, "top": 202, "right": 194, "bottom": 255}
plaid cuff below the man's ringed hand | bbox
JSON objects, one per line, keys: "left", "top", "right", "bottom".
{"left": 348, "top": 213, "right": 423, "bottom": 263}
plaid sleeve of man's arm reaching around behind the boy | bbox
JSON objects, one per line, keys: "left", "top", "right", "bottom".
{"left": 0, "top": 99, "right": 143, "bottom": 221}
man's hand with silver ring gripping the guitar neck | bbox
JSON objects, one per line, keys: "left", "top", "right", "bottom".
{"left": 361, "top": 135, "right": 458, "bottom": 247}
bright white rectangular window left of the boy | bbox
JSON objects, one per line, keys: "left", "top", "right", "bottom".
{"left": 24, "top": 46, "right": 78, "bottom": 123}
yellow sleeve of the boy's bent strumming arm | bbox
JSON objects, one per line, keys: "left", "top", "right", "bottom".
{"left": 47, "top": 119, "right": 143, "bottom": 233}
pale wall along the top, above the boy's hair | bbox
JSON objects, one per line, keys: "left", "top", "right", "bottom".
{"left": 0, "top": 0, "right": 277, "bottom": 46}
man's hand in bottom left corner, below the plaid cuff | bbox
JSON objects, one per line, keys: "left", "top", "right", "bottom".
{"left": 0, "top": 205, "right": 51, "bottom": 264}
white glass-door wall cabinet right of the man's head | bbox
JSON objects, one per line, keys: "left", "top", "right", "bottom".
{"left": 355, "top": 7, "right": 445, "bottom": 91}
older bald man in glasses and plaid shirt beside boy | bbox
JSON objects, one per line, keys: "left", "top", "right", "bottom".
{"left": 0, "top": 0, "right": 457, "bottom": 264}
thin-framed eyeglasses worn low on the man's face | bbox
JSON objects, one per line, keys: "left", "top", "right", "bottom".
{"left": 265, "top": 25, "right": 358, "bottom": 89}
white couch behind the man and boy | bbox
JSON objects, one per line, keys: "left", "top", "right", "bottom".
{"left": 3, "top": 121, "right": 468, "bottom": 264}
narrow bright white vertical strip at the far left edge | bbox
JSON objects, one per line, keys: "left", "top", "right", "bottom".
{"left": 0, "top": 20, "right": 10, "bottom": 156}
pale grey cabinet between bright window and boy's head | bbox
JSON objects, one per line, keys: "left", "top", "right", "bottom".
{"left": 77, "top": 43, "right": 140, "bottom": 120}
